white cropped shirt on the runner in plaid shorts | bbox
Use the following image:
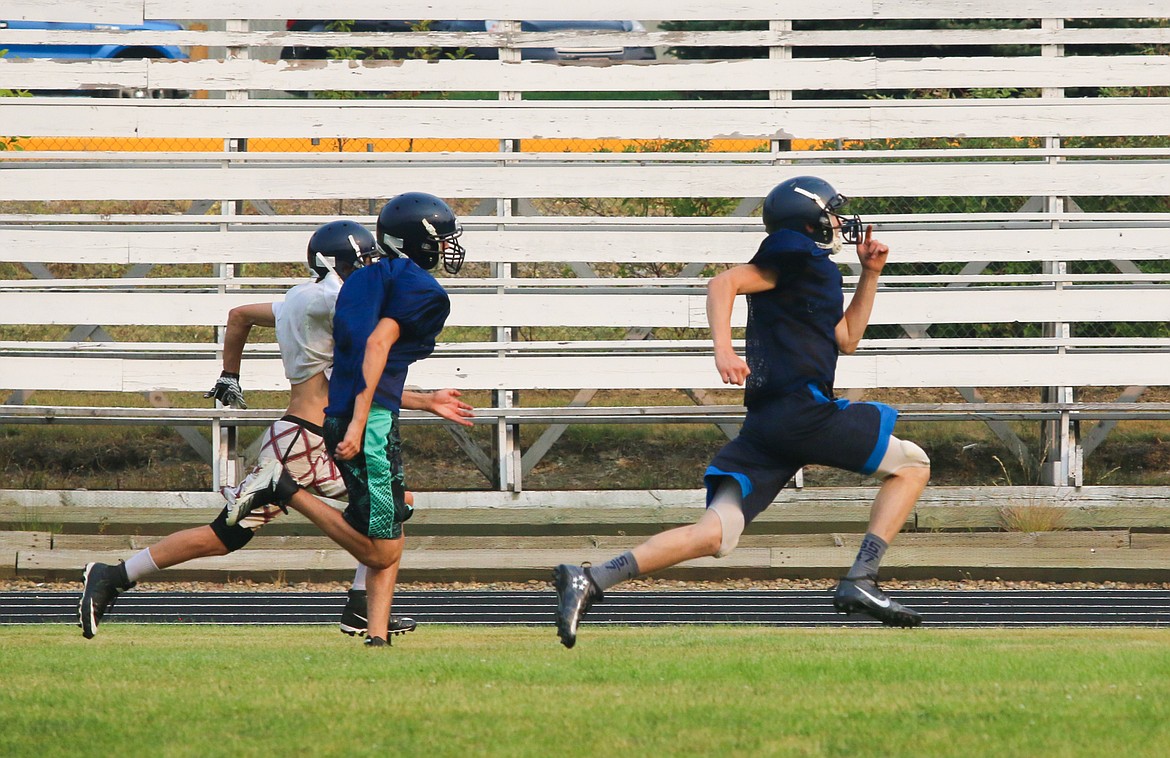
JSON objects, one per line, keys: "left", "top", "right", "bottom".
{"left": 273, "top": 274, "right": 342, "bottom": 384}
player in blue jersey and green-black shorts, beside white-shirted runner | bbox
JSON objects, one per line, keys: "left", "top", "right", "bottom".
{"left": 228, "top": 192, "right": 464, "bottom": 647}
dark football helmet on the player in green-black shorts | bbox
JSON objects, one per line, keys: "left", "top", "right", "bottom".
{"left": 378, "top": 192, "right": 466, "bottom": 274}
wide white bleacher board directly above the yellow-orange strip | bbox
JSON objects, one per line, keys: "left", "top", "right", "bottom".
{"left": 4, "top": 97, "right": 1170, "bottom": 140}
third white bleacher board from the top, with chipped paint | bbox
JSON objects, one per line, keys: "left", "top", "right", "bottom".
{"left": 9, "top": 55, "right": 1170, "bottom": 92}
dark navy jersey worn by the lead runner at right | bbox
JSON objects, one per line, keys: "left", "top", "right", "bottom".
{"left": 744, "top": 229, "right": 845, "bottom": 407}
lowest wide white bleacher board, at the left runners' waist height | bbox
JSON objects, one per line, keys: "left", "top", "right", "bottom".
{"left": 9, "top": 351, "right": 1170, "bottom": 392}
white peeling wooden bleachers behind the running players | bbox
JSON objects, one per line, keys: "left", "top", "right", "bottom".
{"left": 0, "top": 0, "right": 1170, "bottom": 490}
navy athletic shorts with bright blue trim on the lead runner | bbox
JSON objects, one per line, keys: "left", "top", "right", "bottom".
{"left": 703, "top": 384, "right": 897, "bottom": 524}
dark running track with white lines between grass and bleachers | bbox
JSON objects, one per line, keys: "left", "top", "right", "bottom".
{"left": 0, "top": 590, "right": 1170, "bottom": 627}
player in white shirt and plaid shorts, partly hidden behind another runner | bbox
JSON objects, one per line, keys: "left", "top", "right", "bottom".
{"left": 78, "top": 220, "right": 472, "bottom": 639}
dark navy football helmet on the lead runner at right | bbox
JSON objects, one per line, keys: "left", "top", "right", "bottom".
{"left": 764, "top": 177, "right": 861, "bottom": 247}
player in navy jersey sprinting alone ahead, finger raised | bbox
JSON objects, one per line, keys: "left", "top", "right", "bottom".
{"left": 553, "top": 177, "right": 930, "bottom": 648}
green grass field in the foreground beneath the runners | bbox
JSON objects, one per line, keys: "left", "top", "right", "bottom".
{"left": 0, "top": 625, "right": 1170, "bottom": 758}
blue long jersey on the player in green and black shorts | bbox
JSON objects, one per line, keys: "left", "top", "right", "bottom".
{"left": 325, "top": 257, "right": 450, "bottom": 416}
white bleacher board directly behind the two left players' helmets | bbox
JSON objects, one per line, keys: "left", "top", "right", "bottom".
{"left": 0, "top": 224, "right": 1170, "bottom": 266}
